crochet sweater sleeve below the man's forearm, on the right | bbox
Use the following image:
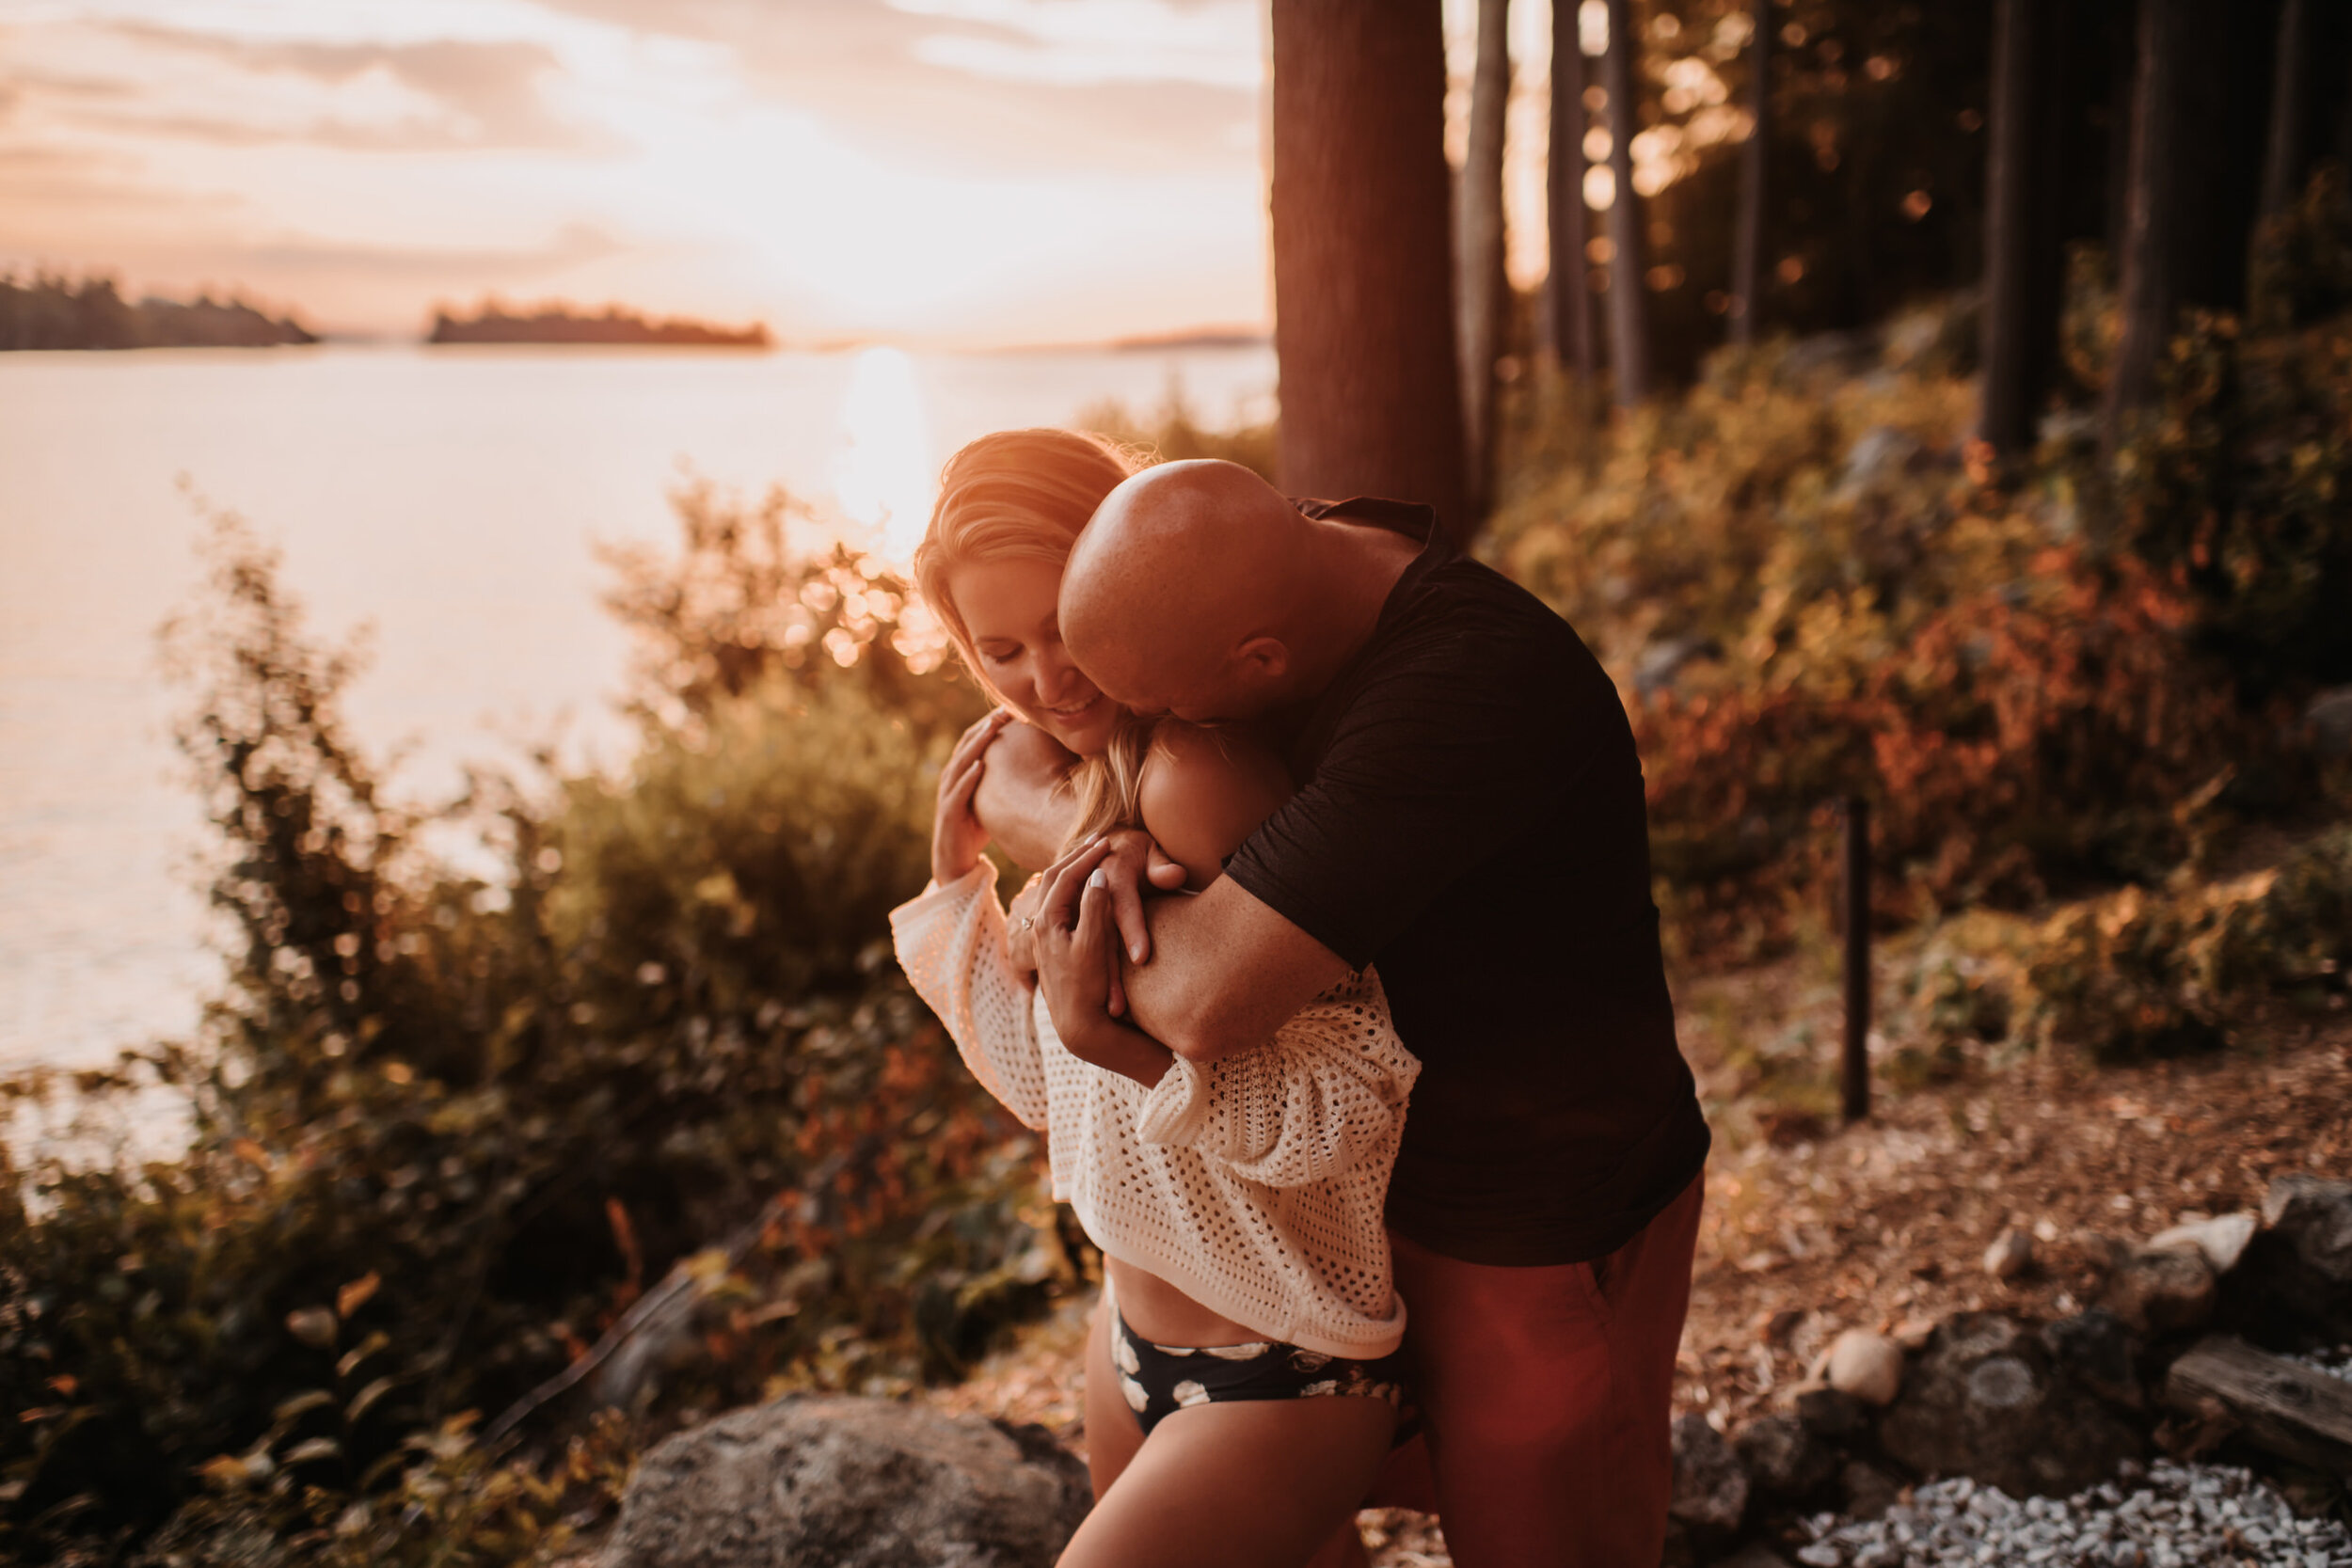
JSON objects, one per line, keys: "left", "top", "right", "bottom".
{"left": 1136, "top": 969, "right": 1421, "bottom": 1187}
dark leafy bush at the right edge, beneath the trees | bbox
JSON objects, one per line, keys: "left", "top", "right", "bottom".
{"left": 2117, "top": 181, "right": 2352, "bottom": 691}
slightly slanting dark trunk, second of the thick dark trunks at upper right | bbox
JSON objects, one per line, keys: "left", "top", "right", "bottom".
{"left": 2101, "top": 0, "right": 2195, "bottom": 458}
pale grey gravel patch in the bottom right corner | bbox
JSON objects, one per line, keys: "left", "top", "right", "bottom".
{"left": 1797, "top": 1460, "right": 2352, "bottom": 1568}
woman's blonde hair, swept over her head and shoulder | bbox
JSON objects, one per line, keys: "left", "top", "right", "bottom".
{"left": 915, "top": 428, "right": 1152, "bottom": 842}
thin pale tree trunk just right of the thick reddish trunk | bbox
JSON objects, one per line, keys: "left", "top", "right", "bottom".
{"left": 1454, "top": 0, "right": 1510, "bottom": 524}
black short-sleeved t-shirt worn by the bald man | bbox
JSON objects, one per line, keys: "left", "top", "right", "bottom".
{"left": 1226, "top": 500, "right": 1708, "bottom": 1265}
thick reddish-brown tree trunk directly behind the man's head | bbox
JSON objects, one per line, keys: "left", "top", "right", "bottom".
{"left": 1273, "top": 0, "right": 1470, "bottom": 536}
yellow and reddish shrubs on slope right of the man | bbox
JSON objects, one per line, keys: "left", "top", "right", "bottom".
{"left": 1489, "top": 326, "right": 2289, "bottom": 959}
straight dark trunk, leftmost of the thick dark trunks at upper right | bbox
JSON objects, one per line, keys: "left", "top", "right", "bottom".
{"left": 1979, "top": 0, "right": 2065, "bottom": 458}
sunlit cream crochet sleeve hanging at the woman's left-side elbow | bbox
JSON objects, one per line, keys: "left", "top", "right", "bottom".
{"left": 889, "top": 861, "right": 1047, "bottom": 1131}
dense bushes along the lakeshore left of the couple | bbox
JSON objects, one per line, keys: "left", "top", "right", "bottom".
{"left": 0, "top": 500, "right": 1071, "bottom": 1563}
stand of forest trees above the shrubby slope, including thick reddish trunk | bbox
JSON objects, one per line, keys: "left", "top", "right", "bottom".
{"left": 1273, "top": 0, "right": 2352, "bottom": 531}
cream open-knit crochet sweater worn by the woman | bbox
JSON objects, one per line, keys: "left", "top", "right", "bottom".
{"left": 892, "top": 861, "right": 1421, "bottom": 1359}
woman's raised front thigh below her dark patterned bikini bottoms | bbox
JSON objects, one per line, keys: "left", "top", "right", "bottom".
{"left": 1061, "top": 1401, "right": 1397, "bottom": 1568}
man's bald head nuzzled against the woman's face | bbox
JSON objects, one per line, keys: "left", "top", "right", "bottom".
{"left": 1061, "top": 458, "right": 1311, "bottom": 717}
